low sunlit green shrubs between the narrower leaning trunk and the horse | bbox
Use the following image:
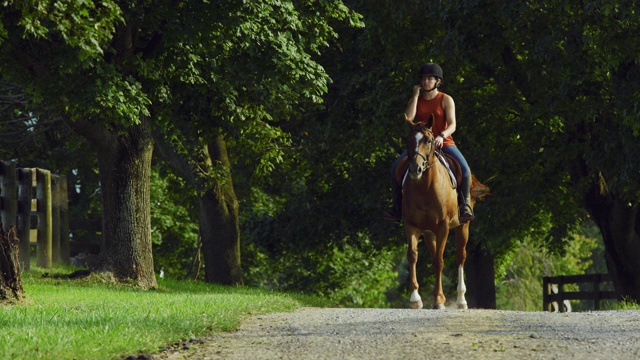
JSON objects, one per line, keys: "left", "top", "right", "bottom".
{"left": 242, "top": 224, "right": 398, "bottom": 307}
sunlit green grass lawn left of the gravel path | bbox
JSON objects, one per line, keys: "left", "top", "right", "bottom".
{"left": 0, "top": 269, "right": 328, "bottom": 359}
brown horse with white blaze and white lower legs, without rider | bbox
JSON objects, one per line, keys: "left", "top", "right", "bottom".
{"left": 402, "top": 115, "right": 489, "bottom": 309}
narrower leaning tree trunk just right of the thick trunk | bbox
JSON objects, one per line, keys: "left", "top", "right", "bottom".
{"left": 200, "top": 136, "right": 242, "bottom": 285}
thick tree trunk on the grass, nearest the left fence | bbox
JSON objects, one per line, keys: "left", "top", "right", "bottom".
{"left": 91, "top": 119, "right": 157, "bottom": 289}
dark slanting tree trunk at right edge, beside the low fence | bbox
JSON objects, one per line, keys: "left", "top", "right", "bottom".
{"left": 586, "top": 175, "right": 640, "bottom": 302}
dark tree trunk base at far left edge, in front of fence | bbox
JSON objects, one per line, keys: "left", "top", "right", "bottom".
{"left": 0, "top": 225, "right": 24, "bottom": 304}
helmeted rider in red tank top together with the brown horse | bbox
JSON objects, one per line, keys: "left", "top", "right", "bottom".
{"left": 392, "top": 63, "right": 489, "bottom": 309}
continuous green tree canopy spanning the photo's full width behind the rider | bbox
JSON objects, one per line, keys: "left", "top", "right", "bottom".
{"left": 0, "top": 0, "right": 640, "bottom": 306}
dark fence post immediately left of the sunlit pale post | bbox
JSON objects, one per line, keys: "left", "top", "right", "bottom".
{"left": 18, "top": 169, "right": 33, "bottom": 271}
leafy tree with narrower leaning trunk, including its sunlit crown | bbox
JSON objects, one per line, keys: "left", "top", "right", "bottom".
{"left": 148, "top": 1, "right": 358, "bottom": 284}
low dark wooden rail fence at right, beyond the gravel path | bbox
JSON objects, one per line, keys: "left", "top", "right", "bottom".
{"left": 542, "top": 274, "right": 617, "bottom": 312}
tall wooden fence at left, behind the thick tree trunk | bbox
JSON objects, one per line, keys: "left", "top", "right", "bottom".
{"left": 0, "top": 161, "right": 70, "bottom": 270}
